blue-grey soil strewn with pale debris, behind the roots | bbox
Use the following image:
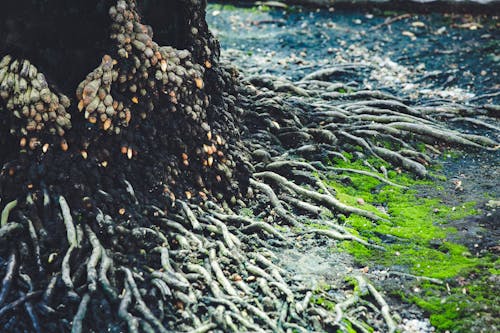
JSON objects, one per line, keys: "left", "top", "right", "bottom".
{"left": 207, "top": 5, "right": 500, "bottom": 103}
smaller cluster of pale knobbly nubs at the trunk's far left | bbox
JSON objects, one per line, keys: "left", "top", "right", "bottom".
{"left": 0, "top": 55, "right": 71, "bottom": 149}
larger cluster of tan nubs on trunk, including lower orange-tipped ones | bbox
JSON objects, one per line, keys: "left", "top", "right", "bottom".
{"left": 83, "top": 0, "right": 242, "bottom": 197}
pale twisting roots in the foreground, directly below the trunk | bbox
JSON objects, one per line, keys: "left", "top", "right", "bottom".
{"left": 0, "top": 176, "right": 402, "bottom": 332}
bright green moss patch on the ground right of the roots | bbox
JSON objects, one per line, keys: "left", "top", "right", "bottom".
{"left": 325, "top": 154, "right": 499, "bottom": 332}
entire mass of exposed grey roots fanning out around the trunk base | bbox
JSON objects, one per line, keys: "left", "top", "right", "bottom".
{"left": 0, "top": 62, "right": 496, "bottom": 332}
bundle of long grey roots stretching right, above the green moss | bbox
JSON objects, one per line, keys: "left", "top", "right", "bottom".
{"left": 241, "top": 74, "right": 498, "bottom": 172}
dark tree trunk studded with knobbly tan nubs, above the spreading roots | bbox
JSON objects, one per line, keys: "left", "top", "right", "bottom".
{"left": 0, "top": 0, "right": 246, "bottom": 202}
